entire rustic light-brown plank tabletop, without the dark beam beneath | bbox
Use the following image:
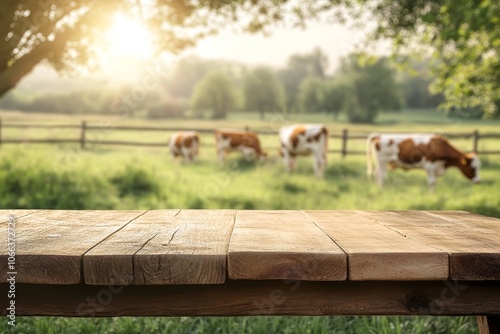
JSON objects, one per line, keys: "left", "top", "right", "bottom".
{"left": 0, "top": 210, "right": 500, "bottom": 285}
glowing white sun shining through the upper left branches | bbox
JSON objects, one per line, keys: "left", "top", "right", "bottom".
{"left": 103, "top": 13, "right": 153, "bottom": 60}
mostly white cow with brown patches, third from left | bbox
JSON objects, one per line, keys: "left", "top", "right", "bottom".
{"left": 280, "top": 124, "right": 328, "bottom": 177}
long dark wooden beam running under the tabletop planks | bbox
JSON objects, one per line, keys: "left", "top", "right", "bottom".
{"left": 0, "top": 280, "right": 500, "bottom": 317}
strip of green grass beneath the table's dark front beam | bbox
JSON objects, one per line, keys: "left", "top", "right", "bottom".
{"left": 0, "top": 316, "right": 477, "bottom": 334}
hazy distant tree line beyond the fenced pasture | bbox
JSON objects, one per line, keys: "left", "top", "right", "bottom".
{"left": 0, "top": 49, "right": 446, "bottom": 123}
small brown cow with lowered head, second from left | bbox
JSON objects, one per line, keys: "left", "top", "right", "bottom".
{"left": 215, "top": 129, "right": 267, "bottom": 164}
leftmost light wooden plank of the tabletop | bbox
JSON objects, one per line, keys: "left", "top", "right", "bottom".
{"left": 0, "top": 210, "right": 143, "bottom": 284}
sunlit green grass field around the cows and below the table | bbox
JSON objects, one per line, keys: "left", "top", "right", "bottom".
{"left": 0, "top": 111, "right": 500, "bottom": 333}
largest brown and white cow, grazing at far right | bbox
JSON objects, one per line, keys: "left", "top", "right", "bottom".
{"left": 367, "top": 134, "right": 481, "bottom": 189}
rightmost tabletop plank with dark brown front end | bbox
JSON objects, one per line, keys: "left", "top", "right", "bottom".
{"left": 363, "top": 211, "right": 500, "bottom": 280}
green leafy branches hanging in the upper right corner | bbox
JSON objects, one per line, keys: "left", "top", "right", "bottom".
{"left": 362, "top": 0, "right": 500, "bottom": 117}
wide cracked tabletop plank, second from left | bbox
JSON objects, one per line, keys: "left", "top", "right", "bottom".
{"left": 84, "top": 210, "right": 235, "bottom": 284}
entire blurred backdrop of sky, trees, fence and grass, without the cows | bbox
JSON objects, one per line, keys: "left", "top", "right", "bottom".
{"left": 0, "top": 0, "right": 500, "bottom": 333}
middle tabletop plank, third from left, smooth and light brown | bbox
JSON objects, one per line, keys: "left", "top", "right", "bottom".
{"left": 228, "top": 210, "right": 347, "bottom": 281}
